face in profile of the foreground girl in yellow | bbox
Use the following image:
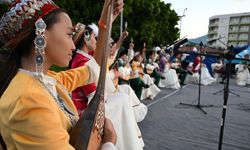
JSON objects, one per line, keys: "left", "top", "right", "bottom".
{"left": 45, "top": 13, "right": 75, "bottom": 67}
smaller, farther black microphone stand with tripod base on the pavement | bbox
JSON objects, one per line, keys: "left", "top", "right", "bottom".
{"left": 180, "top": 42, "right": 213, "bottom": 114}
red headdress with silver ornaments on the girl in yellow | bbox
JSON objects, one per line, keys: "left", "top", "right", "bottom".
{"left": 0, "top": 0, "right": 59, "bottom": 43}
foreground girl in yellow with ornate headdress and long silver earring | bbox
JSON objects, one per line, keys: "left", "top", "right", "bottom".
{"left": 0, "top": 0, "right": 123, "bottom": 150}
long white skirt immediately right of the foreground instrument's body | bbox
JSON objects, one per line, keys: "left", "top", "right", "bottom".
{"left": 105, "top": 93, "right": 144, "bottom": 150}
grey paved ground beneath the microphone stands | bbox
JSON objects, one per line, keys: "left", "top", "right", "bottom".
{"left": 139, "top": 81, "right": 250, "bottom": 150}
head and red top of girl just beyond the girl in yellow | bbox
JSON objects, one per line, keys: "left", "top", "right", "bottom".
{"left": 70, "top": 23, "right": 98, "bottom": 116}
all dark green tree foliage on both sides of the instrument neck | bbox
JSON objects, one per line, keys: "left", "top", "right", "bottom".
{"left": 0, "top": 0, "right": 179, "bottom": 50}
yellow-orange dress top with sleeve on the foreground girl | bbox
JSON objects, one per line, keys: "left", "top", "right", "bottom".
{"left": 0, "top": 67, "right": 91, "bottom": 150}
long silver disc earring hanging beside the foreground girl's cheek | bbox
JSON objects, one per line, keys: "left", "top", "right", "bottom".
{"left": 34, "top": 18, "right": 46, "bottom": 81}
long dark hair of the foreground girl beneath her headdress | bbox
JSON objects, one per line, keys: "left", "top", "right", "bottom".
{"left": 0, "top": 8, "right": 65, "bottom": 97}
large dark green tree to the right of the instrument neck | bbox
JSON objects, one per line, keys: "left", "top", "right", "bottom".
{"left": 121, "top": 0, "right": 179, "bottom": 49}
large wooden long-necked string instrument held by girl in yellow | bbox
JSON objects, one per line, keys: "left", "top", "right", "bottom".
{"left": 70, "top": 0, "right": 114, "bottom": 150}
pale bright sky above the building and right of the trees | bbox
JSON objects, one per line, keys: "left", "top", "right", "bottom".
{"left": 162, "top": 0, "right": 250, "bottom": 38}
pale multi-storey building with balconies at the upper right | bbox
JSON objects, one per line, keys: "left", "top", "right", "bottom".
{"left": 208, "top": 12, "right": 250, "bottom": 48}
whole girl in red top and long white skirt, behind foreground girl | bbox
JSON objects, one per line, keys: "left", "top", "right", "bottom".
{"left": 71, "top": 23, "right": 147, "bottom": 150}
